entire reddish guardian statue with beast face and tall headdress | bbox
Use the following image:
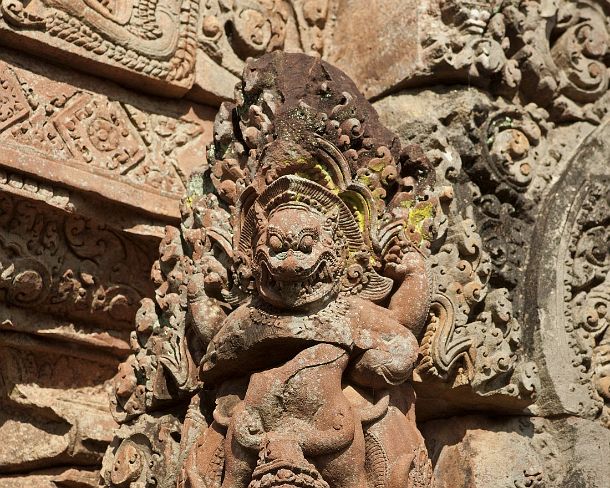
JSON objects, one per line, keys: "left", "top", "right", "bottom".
{"left": 104, "top": 54, "right": 440, "bottom": 487}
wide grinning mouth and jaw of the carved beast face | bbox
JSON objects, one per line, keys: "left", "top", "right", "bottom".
{"left": 258, "top": 259, "right": 337, "bottom": 308}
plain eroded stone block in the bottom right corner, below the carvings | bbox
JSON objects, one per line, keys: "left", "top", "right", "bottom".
{"left": 422, "top": 416, "right": 610, "bottom": 488}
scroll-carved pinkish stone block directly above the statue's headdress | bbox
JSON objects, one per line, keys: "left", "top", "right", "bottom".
{"left": 191, "top": 0, "right": 336, "bottom": 104}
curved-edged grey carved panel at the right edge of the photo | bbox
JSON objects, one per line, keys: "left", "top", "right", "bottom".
{"left": 525, "top": 119, "right": 610, "bottom": 424}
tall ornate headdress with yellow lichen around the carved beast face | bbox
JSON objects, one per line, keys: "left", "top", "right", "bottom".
{"left": 184, "top": 53, "right": 437, "bottom": 303}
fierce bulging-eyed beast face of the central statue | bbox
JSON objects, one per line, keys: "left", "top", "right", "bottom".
{"left": 255, "top": 203, "right": 344, "bottom": 308}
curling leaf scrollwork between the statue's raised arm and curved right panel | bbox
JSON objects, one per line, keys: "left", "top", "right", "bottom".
{"left": 418, "top": 221, "right": 537, "bottom": 402}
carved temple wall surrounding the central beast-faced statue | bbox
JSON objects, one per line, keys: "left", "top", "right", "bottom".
{"left": 0, "top": 0, "right": 610, "bottom": 488}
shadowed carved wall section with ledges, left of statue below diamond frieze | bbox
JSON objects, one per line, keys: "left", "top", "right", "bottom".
{"left": 0, "top": 188, "right": 156, "bottom": 487}
